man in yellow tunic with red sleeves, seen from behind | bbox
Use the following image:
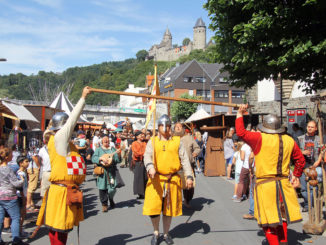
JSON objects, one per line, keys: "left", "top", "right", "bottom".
{"left": 235, "top": 105, "right": 305, "bottom": 245}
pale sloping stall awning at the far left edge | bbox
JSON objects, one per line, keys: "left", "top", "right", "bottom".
{"left": 0, "top": 100, "right": 39, "bottom": 122}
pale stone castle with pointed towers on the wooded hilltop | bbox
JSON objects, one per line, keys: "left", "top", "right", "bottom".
{"left": 148, "top": 18, "right": 206, "bottom": 61}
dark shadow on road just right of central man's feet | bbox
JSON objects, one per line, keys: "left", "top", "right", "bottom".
{"left": 169, "top": 220, "right": 211, "bottom": 238}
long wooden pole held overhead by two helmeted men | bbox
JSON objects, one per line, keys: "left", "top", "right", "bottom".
{"left": 90, "top": 88, "right": 240, "bottom": 107}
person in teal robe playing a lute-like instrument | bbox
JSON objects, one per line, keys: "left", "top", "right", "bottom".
{"left": 92, "top": 135, "right": 119, "bottom": 212}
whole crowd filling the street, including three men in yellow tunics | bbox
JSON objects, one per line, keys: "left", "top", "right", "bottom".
{"left": 0, "top": 87, "right": 323, "bottom": 245}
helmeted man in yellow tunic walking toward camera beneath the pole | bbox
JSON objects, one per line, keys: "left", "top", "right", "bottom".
{"left": 143, "top": 115, "right": 193, "bottom": 245}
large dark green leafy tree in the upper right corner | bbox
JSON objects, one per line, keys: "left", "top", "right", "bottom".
{"left": 204, "top": 0, "right": 326, "bottom": 92}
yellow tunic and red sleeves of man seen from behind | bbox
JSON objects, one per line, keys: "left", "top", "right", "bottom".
{"left": 236, "top": 117, "right": 305, "bottom": 226}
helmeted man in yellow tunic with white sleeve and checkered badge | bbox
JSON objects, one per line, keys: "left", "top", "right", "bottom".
{"left": 37, "top": 87, "right": 90, "bottom": 245}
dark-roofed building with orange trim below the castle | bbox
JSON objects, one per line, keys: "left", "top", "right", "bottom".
{"left": 159, "top": 60, "right": 245, "bottom": 115}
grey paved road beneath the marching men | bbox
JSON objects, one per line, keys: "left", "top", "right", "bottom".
{"left": 5, "top": 167, "right": 326, "bottom": 245}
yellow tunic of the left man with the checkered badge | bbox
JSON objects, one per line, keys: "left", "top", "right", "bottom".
{"left": 36, "top": 136, "right": 86, "bottom": 232}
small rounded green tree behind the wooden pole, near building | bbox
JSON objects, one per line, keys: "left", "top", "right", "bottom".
{"left": 171, "top": 93, "right": 199, "bottom": 122}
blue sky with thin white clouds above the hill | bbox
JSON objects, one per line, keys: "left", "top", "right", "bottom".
{"left": 0, "top": 0, "right": 213, "bottom": 75}
